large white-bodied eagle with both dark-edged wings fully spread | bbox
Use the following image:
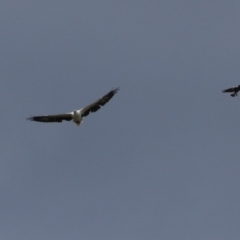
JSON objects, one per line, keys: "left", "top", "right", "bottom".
{"left": 27, "top": 88, "right": 119, "bottom": 126}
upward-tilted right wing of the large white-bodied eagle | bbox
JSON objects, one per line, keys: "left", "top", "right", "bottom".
{"left": 81, "top": 88, "right": 119, "bottom": 117}
